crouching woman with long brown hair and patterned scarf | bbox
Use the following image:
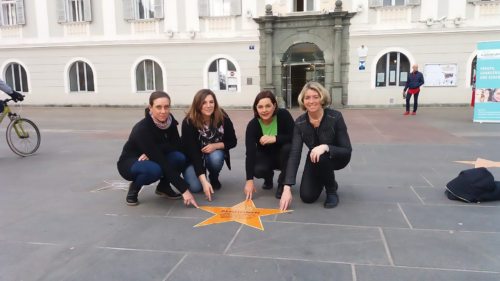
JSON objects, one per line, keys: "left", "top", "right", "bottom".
{"left": 182, "top": 89, "right": 236, "bottom": 201}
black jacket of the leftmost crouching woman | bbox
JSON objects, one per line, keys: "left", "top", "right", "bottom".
{"left": 117, "top": 114, "right": 188, "bottom": 193}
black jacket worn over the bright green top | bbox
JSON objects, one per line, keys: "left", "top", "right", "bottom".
{"left": 245, "top": 108, "right": 294, "bottom": 180}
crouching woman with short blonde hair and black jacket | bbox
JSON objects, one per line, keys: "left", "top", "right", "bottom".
{"left": 280, "top": 82, "right": 352, "bottom": 210}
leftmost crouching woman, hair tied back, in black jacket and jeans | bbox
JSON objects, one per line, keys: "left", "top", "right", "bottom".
{"left": 117, "top": 91, "right": 198, "bottom": 207}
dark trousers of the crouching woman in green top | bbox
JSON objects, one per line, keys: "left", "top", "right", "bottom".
{"left": 254, "top": 143, "right": 291, "bottom": 184}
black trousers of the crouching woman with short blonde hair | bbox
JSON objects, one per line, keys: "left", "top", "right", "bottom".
{"left": 300, "top": 152, "right": 345, "bottom": 203}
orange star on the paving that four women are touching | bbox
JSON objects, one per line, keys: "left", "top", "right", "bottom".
{"left": 194, "top": 200, "right": 290, "bottom": 231}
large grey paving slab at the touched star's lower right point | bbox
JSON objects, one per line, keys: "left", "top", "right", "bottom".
{"left": 228, "top": 222, "right": 389, "bottom": 264}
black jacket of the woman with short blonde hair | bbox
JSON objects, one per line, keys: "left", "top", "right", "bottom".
{"left": 283, "top": 108, "right": 352, "bottom": 185}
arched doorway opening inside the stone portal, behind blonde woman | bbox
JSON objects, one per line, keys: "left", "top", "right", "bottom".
{"left": 281, "top": 43, "right": 325, "bottom": 108}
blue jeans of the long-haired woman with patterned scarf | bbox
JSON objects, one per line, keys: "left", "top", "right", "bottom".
{"left": 184, "top": 150, "right": 224, "bottom": 193}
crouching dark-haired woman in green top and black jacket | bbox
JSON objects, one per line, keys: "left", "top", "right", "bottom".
{"left": 244, "top": 91, "right": 294, "bottom": 200}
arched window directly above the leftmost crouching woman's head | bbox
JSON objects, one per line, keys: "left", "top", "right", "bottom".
{"left": 135, "top": 59, "right": 163, "bottom": 92}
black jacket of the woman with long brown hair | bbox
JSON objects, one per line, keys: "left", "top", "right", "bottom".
{"left": 181, "top": 115, "right": 237, "bottom": 176}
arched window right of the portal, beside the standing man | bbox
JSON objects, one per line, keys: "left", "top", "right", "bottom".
{"left": 375, "top": 52, "right": 410, "bottom": 87}
